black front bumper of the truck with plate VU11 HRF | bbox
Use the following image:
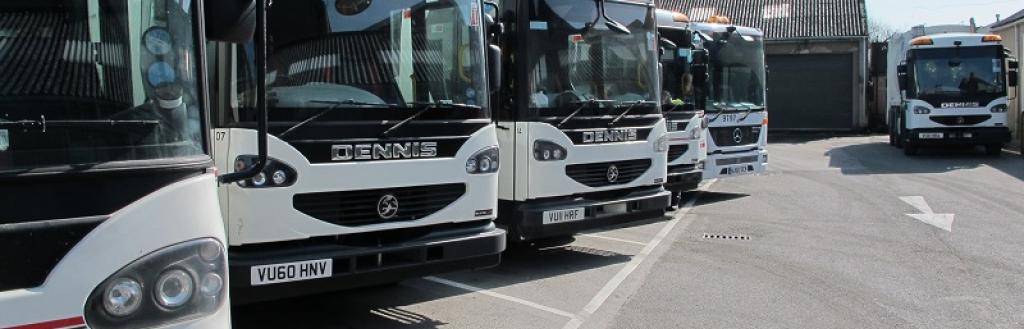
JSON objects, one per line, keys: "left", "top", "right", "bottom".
{"left": 498, "top": 186, "right": 672, "bottom": 241}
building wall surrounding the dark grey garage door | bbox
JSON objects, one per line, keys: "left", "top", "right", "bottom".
{"left": 765, "top": 37, "right": 868, "bottom": 130}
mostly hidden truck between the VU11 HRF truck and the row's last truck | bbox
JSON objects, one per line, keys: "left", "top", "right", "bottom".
{"left": 656, "top": 9, "right": 708, "bottom": 205}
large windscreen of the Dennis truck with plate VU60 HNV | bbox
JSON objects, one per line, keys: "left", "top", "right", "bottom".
{"left": 239, "top": 0, "right": 489, "bottom": 124}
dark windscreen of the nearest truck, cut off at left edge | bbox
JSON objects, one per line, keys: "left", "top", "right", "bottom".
{"left": 0, "top": 0, "right": 206, "bottom": 174}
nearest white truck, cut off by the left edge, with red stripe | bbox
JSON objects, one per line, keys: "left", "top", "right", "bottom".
{"left": 0, "top": 0, "right": 259, "bottom": 329}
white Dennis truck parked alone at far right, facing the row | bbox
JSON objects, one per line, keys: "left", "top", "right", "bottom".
{"left": 887, "top": 29, "right": 1019, "bottom": 155}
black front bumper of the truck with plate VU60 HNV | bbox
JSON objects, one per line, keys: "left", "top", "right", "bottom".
{"left": 228, "top": 220, "right": 505, "bottom": 304}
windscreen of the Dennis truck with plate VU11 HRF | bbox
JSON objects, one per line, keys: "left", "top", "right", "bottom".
{"left": 525, "top": 0, "right": 658, "bottom": 111}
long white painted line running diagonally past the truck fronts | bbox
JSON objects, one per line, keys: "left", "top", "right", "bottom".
{"left": 562, "top": 179, "right": 718, "bottom": 329}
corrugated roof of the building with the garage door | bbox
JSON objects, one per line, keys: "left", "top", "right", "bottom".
{"left": 655, "top": 0, "right": 867, "bottom": 40}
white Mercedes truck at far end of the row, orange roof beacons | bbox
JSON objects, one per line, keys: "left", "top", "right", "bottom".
{"left": 690, "top": 16, "right": 768, "bottom": 179}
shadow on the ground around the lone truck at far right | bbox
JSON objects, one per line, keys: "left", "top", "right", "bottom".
{"left": 825, "top": 138, "right": 1024, "bottom": 180}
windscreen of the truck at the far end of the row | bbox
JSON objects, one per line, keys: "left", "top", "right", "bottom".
{"left": 708, "top": 33, "right": 765, "bottom": 111}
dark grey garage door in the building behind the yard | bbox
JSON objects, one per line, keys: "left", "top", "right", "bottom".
{"left": 766, "top": 54, "right": 853, "bottom": 130}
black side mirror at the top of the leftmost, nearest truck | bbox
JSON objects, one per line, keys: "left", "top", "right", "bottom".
{"left": 203, "top": 0, "right": 258, "bottom": 43}
